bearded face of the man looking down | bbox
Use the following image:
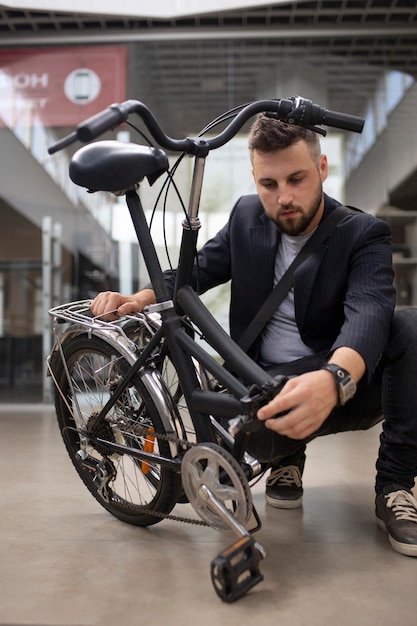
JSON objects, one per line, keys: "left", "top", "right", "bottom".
{"left": 252, "top": 140, "right": 328, "bottom": 235}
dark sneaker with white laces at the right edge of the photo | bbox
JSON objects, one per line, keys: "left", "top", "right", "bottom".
{"left": 375, "top": 485, "right": 417, "bottom": 556}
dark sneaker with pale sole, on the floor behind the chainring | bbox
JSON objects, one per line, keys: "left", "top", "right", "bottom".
{"left": 265, "top": 465, "right": 303, "bottom": 509}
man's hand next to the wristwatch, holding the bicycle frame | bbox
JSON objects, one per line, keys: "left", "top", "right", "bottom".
{"left": 258, "top": 370, "right": 338, "bottom": 439}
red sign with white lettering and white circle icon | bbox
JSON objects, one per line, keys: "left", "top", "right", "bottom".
{"left": 0, "top": 46, "right": 126, "bottom": 127}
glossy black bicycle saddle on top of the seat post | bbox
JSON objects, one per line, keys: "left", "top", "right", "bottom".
{"left": 69, "top": 140, "right": 169, "bottom": 193}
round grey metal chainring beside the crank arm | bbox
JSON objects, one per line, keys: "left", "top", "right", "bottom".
{"left": 181, "top": 443, "right": 252, "bottom": 531}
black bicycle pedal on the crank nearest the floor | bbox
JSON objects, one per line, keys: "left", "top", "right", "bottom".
{"left": 210, "top": 536, "right": 264, "bottom": 603}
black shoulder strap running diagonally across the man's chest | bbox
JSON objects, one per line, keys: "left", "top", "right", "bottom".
{"left": 237, "top": 206, "right": 352, "bottom": 352}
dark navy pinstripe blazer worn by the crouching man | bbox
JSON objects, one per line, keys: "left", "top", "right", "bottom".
{"left": 164, "top": 190, "right": 395, "bottom": 376}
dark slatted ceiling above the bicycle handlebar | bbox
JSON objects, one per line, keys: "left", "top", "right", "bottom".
{"left": 0, "top": 0, "right": 417, "bottom": 137}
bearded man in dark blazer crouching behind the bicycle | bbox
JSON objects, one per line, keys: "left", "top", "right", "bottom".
{"left": 91, "top": 115, "right": 417, "bottom": 556}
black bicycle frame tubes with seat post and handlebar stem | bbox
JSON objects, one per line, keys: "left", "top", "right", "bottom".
{"left": 122, "top": 176, "right": 274, "bottom": 441}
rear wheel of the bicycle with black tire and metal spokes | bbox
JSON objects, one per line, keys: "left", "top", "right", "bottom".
{"left": 54, "top": 333, "right": 181, "bottom": 526}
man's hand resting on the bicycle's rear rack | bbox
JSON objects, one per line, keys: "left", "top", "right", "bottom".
{"left": 90, "top": 289, "right": 155, "bottom": 320}
